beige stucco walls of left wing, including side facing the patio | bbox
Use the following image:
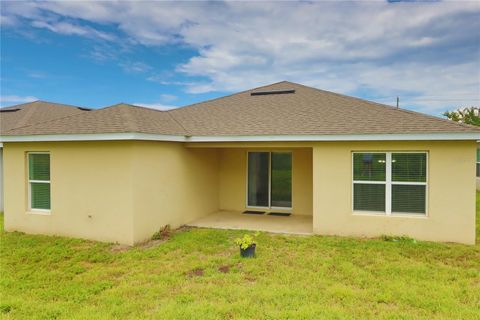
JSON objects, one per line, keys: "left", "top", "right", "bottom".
{"left": 5, "top": 141, "right": 218, "bottom": 244}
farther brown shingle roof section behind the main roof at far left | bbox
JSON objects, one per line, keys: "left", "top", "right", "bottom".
{"left": 0, "top": 101, "right": 85, "bottom": 135}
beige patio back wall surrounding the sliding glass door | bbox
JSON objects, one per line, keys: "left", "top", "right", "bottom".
{"left": 219, "top": 146, "right": 313, "bottom": 215}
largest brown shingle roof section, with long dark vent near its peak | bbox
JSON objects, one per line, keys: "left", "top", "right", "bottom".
{"left": 170, "top": 81, "right": 480, "bottom": 136}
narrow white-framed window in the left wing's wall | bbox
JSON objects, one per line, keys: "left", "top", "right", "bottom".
{"left": 27, "top": 152, "right": 50, "bottom": 212}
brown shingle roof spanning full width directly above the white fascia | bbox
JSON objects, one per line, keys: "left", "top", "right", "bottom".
{"left": 2, "top": 81, "right": 480, "bottom": 136}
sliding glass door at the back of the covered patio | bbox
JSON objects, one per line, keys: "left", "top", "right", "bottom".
{"left": 247, "top": 152, "right": 292, "bottom": 208}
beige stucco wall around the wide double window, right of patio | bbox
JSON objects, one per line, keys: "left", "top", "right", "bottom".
{"left": 313, "top": 141, "right": 476, "bottom": 244}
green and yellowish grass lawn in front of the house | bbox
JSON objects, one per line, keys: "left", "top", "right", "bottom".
{"left": 0, "top": 194, "right": 480, "bottom": 319}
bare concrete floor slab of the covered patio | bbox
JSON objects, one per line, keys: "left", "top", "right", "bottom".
{"left": 187, "top": 211, "right": 313, "bottom": 235}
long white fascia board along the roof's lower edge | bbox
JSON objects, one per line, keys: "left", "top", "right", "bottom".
{"left": 0, "top": 132, "right": 480, "bottom": 143}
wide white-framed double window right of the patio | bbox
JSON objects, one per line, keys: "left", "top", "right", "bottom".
{"left": 352, "top": 151, "right": 428, "bottom": 215}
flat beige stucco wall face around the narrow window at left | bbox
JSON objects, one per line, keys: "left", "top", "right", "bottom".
{"left": 4, "top": 141, "right": 133, "bottom": 243}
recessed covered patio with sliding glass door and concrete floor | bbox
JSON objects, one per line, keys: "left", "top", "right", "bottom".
{"left": 182, "top": 143, "right": 313, "bottom": 235}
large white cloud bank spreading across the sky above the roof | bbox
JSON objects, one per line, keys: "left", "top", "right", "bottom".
{"left": 2, "top": 1, "right": 480, "bottom": 114}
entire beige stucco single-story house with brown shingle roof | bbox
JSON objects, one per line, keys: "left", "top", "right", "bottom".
{"left": 0, "top": 81, "right": 480, "bottom": 245}
